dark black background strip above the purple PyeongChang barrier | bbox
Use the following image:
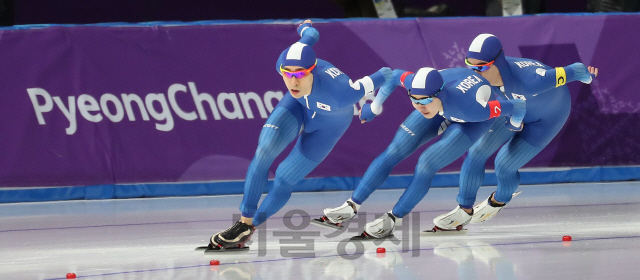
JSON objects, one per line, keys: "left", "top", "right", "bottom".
{"left": 7, "top": 0, "right": 608, "bottom": 24}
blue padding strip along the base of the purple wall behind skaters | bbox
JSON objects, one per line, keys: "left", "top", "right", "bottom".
{"left": 0, "top": 166, "right": 640, "bottom": 203}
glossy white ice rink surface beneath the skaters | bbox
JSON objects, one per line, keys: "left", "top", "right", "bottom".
{"left": 0, "top": 182, "right": 640, "bottom": 280}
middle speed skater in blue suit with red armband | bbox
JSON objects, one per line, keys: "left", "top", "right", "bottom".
{"left": 314, "top": 68, "right": 526, "bottom": 238}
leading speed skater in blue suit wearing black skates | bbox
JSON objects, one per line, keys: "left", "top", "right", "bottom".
{"left": 208, "top": 20, "right": 392, "bottom": 250}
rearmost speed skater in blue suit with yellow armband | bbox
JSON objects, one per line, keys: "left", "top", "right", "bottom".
{"left": 433, "top": 34, "right": 598, "bottom": 228}
